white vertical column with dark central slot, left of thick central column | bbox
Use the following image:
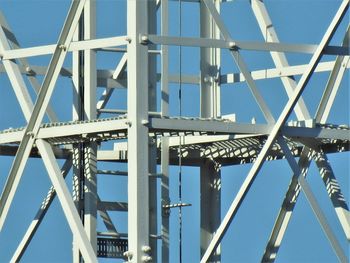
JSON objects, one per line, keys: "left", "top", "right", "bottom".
{"left": 73, "top": 0, "right": 97, "bottom": 262}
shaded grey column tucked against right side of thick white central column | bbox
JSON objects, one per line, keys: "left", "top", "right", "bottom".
{"left": 148, "top": 1, "right": 158, "bottom": 262}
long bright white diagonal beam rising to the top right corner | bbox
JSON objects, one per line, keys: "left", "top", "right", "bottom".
{"left": 201, "top": 0, "right": 349, "bottom": 263}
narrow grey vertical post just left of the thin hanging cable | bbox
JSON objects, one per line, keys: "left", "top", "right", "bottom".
{"left": 161, "top": 0, "right": 170, "bottom": 263}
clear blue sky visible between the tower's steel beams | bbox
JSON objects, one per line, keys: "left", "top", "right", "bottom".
{"left": 0, "top": 0, "right": 350, "bottom": 263}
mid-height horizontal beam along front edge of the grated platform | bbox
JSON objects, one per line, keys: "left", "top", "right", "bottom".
{"left": 0, "top": 118, "right": 350, "bottom": 144}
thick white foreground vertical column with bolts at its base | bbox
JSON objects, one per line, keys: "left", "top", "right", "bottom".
{"left": 127, "top": 1, "right": 151, "bottom": 263}
